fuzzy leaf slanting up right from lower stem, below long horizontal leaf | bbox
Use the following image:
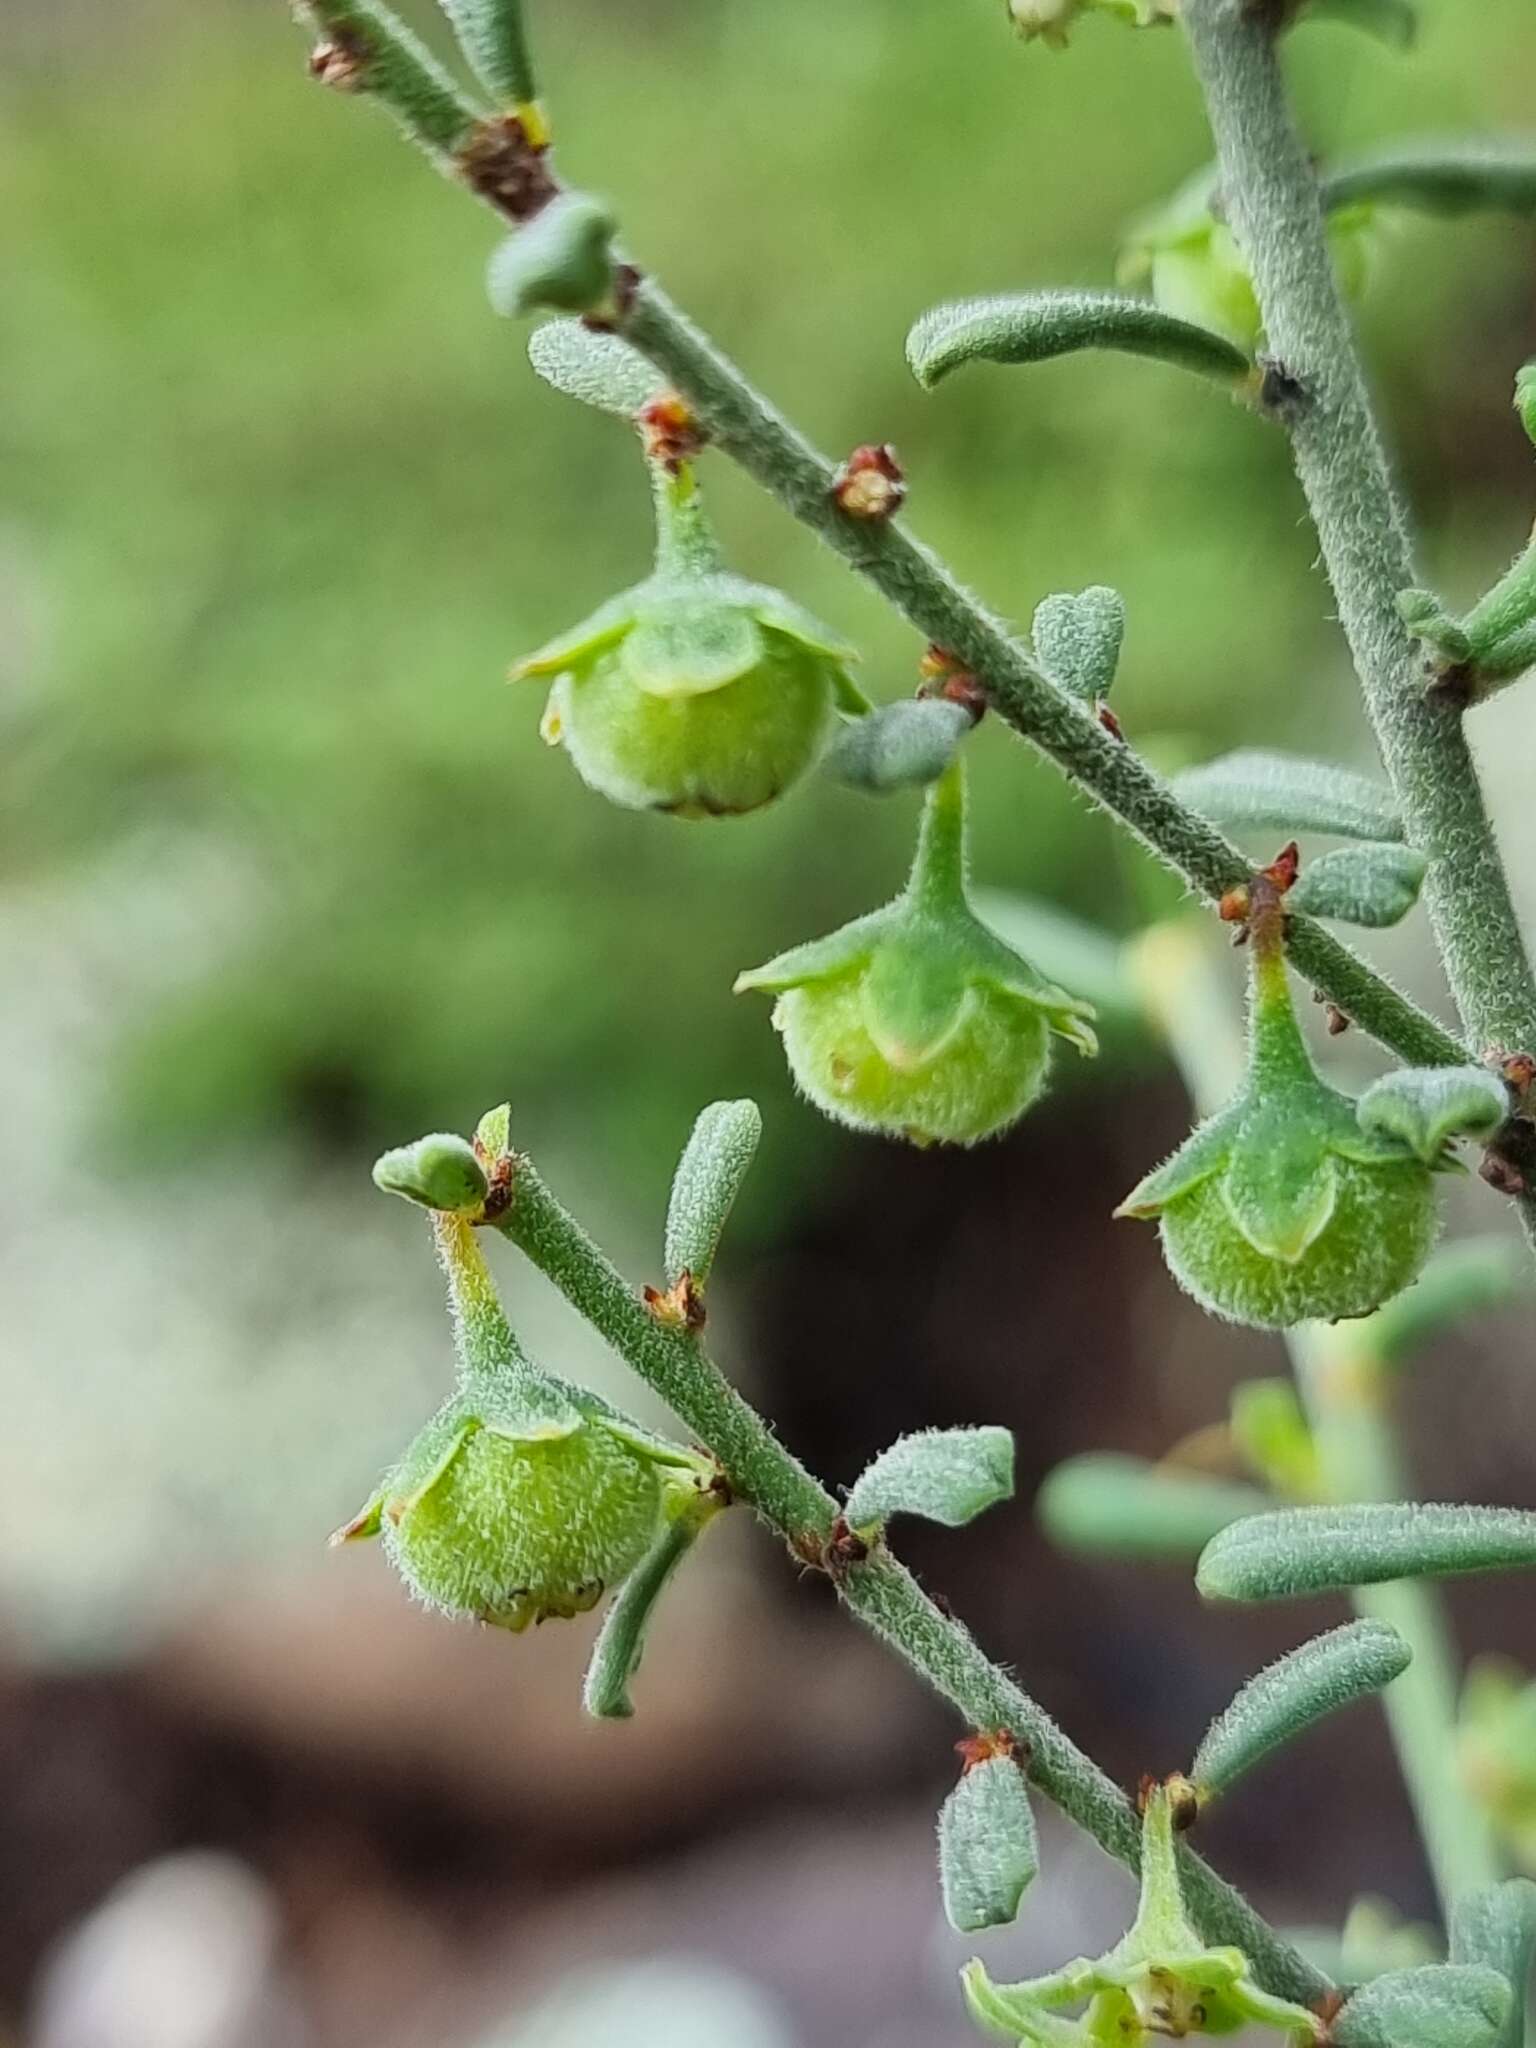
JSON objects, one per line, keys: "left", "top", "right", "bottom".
{"left": 1190, "top": 1622, "right": 1413, "bottom": 1794}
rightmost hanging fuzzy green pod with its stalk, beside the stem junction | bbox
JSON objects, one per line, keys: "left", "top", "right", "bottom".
{"left": 1116, "top": 879, "right": 1436, "bottom": 1329}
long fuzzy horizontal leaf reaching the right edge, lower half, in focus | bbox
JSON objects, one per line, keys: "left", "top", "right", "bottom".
{"left": 1194, "top": 1501, "right": 1536, "bottom": 1599}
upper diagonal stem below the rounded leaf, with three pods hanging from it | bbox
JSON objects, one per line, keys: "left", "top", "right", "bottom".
{"left": 623, "top": 281, "right": 1466, "bottom": 1067}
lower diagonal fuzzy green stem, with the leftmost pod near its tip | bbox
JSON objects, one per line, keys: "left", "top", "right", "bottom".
{"left": 496, "top": 1157, "right": 1329, "bottom": 2001}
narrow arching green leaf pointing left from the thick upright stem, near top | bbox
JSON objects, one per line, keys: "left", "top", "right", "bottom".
{"left": 907, "top": 291, "right": 1253, "bottom": 389}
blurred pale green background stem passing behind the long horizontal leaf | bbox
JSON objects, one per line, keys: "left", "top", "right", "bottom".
{"left": 1286, "top": 1319, "right": 1505, "bottom": 1925}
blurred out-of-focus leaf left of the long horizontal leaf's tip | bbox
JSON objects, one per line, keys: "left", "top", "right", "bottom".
{"left": 1034, "top": 1452, "right": 1268, "bottom": 1563}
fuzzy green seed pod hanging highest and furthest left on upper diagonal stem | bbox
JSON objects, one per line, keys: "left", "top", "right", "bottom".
{"left": 512, "top": 463, "right": 862, "bottom": 817}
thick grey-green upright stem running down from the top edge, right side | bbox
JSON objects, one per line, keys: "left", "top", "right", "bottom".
{"left": 1180, "top": 0, "right": 1536, "bottom": 1171}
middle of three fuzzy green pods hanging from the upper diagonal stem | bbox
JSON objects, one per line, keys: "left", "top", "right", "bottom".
{"left": 735, "top": 762, "right": 1096, "bottom": 1145}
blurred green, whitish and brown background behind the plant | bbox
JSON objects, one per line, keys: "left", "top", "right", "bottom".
{"left": 0, "top": 0, "right": 1536, "bottom": 2048}
